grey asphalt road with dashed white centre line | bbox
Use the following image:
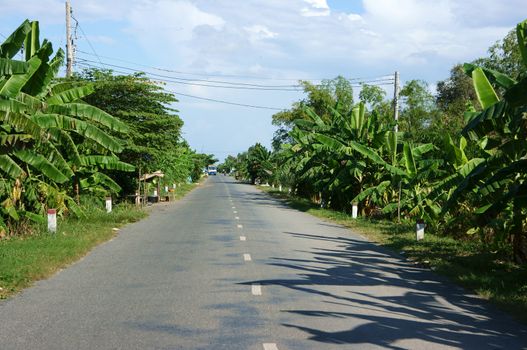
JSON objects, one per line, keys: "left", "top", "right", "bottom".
{"left": 0, "top": 176, "right": 527, "bottom": 350}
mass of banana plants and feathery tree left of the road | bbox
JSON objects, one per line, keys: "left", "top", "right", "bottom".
{"left": 0, "top": 20, "right": 210, "bottom": 238}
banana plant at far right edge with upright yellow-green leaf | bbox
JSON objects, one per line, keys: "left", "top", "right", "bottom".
{"left": 449, "top": 17, "right": 527, "bottom": 263}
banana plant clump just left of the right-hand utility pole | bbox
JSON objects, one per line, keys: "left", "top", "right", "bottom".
{"left": 290, "top": 102, "right": 402, "bottom": 210}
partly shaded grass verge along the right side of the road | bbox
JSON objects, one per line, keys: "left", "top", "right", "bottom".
{"left": 261, "top": 187, "right": 527, "bottom": 323}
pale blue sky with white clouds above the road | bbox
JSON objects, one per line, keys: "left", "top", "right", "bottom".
{"left": 0, "top": 0, "right": 525, "bottom": 159}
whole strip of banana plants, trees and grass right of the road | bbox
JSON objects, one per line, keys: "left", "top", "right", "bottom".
{"left": 221, "top": 21, "right": 527, "bottom": 315}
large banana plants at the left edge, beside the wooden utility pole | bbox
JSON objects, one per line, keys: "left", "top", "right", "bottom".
{"left": 0, "top": 21, "right": 132, "bottom": 232}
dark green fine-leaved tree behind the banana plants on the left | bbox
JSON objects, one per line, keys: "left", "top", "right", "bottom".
{"left": 77, "top": 69, "right": 193, "bottom": 193}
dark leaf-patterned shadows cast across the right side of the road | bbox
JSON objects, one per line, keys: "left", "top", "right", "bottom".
{"left": 240, "top": 232, "right": 527, "bottom": 349}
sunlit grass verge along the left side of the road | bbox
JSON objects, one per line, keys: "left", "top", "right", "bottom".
{"left": 0, "top": 184, "right": 198, "bottom": 299}
